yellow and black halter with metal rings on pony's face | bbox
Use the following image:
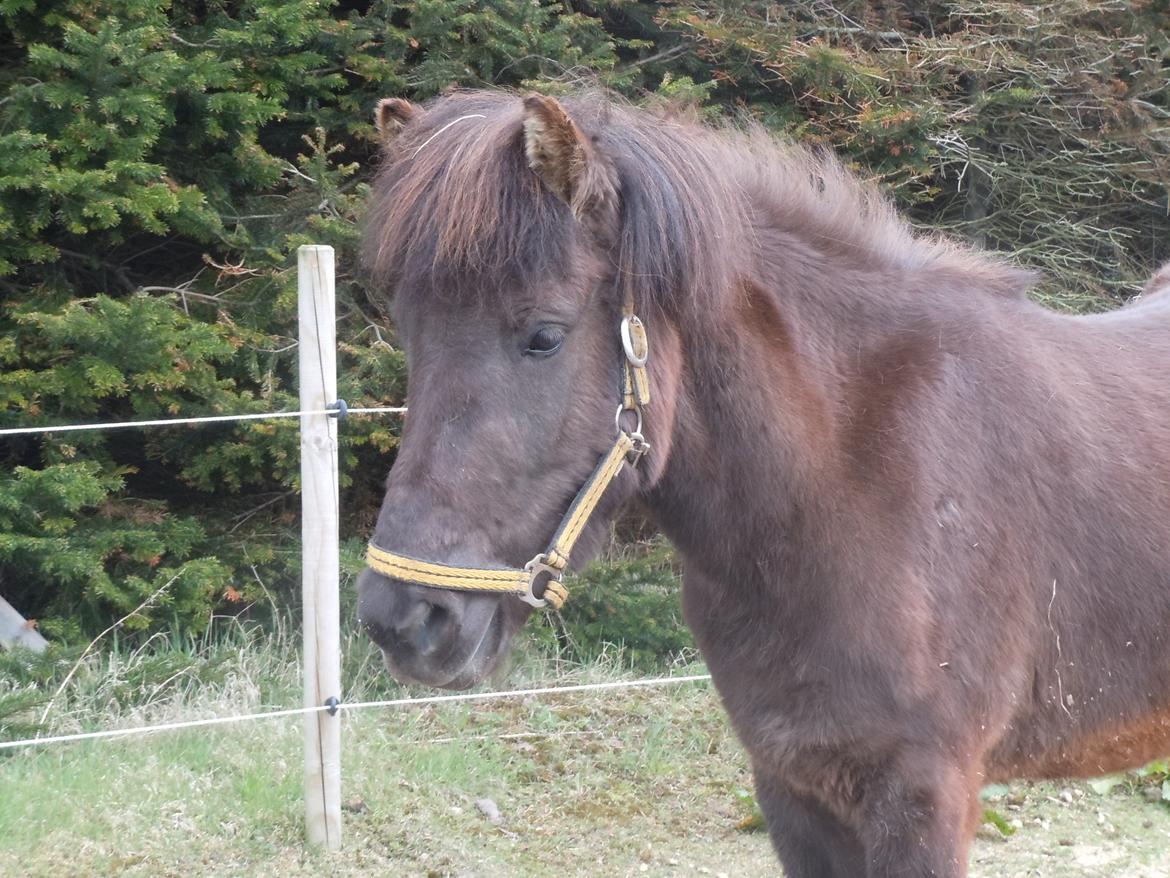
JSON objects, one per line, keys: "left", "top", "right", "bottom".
{"left": 366, "top": 299, "right": 651, "bottom": 610}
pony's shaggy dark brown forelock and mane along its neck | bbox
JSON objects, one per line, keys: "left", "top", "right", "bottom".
{"left": 365, "top": 91, "right": 1027, "bottom": 311}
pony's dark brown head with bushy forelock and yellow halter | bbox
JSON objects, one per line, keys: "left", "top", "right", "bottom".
{"left": 358, "top": 92, "right": 732, "bottom": 688}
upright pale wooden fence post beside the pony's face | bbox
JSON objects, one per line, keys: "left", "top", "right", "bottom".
{"left": 297, "top": 246, "right": 342, "bottom": 850}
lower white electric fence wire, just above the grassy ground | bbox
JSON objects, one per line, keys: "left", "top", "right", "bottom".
{"left": 0, "top": 674, "right": 711, "bottom": 750}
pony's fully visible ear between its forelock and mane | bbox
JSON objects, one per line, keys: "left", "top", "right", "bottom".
{"left": 524, "top": 95, "right": 618, "bottom": 232}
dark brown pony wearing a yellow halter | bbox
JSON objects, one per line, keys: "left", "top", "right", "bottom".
{"left": 359, "top": 92, "right": 1170, "bottom": 878}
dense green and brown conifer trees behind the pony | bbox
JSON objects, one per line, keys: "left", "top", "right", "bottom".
{"left": 0, "top": 0, "right": 1170, "bottom": 658}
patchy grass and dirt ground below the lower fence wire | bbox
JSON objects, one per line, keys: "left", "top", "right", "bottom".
{"left": 0, "top": 678, "right": 1170, "bottom": 878}
